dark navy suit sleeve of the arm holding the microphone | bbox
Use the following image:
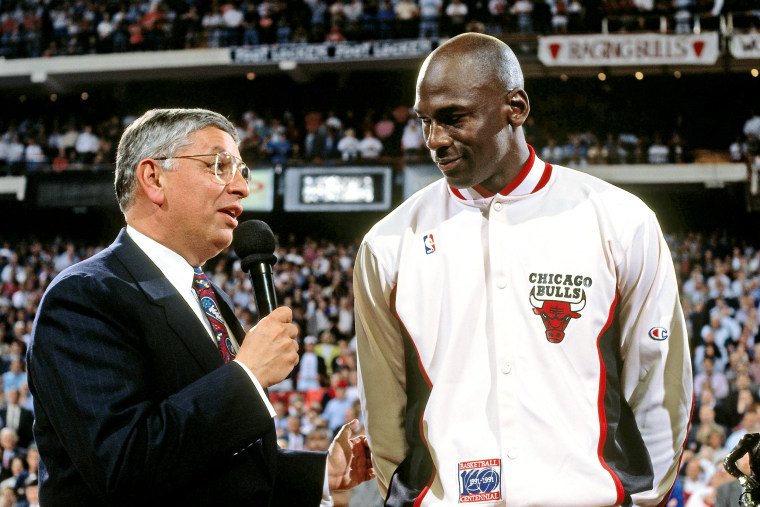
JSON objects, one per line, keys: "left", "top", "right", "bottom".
{"left": 28, "top": 274, "right": 280, "bottom": 500}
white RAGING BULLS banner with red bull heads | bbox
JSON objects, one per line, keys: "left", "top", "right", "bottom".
{"left": 538, "top": 32, "right": 720, "bottom": 67}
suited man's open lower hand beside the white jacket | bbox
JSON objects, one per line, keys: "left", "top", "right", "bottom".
{"left": 327, "top": 419, "right": 375, "bottom": 491}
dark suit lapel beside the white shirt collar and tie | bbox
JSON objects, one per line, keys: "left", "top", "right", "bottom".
{"left": 111, "top": 229, "right": 223, "bottom": 371}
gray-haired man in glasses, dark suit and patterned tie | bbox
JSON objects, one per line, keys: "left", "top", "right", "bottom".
{"left": 28, "top": 109, "right": 373, "bottom": 507}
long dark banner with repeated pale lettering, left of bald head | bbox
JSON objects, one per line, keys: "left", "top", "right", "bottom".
{"left": 231, "top": 39, "right": 435, "bottom": 65}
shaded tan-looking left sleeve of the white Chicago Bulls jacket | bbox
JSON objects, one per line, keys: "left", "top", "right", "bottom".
{"left": 354, "top": 242, "right": 408, "bottom": 497}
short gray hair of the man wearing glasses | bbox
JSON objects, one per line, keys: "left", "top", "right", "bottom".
{"left": 114, "top": 109, "right": 240, "bottom": 213}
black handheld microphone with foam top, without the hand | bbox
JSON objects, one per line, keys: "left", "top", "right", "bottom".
{"left": 232, "top": 220, "right": 277, "bottom": 318}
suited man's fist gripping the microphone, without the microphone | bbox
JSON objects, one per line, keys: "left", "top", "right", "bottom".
{"left": 235, "top": 306, "right": 298, "bottom": 388}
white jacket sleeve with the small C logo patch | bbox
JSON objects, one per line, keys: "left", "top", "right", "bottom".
{"left": 617, "top": 212, "right": 693, "bottom": 505}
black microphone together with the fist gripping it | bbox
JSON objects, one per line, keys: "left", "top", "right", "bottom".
{"left": 232, "top": 220, "right": 298, "bottom": 388}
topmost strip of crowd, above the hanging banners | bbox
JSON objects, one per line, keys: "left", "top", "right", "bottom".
{"left": 0, "top": 0, "right": 760, "bottom": 58}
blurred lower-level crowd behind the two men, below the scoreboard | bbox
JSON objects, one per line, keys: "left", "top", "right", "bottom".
{"left": 0, "top": 224, "right": 760, "bottom": 507}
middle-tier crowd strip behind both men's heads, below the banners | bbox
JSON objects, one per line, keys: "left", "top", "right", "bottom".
{"left": 0, "top": 105, "right": 747, "bottom": 176}
